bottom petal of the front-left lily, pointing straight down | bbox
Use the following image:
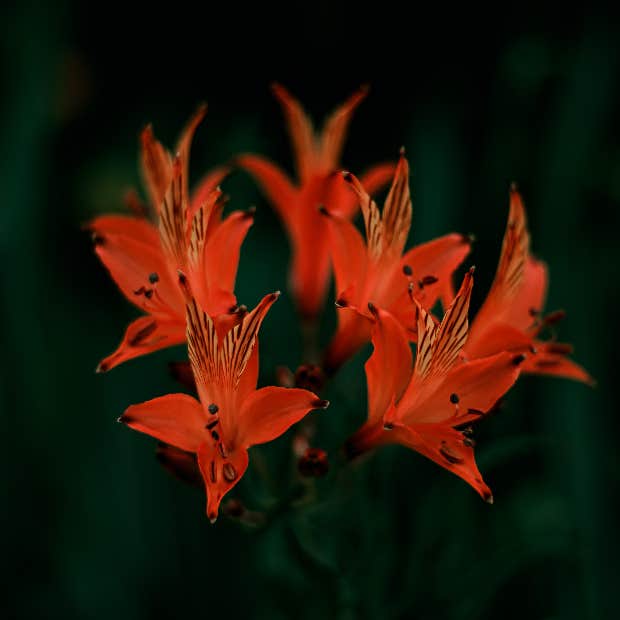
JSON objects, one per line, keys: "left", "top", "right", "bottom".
{"left": 198, "top": 441, "right": 248, "bottom": 523}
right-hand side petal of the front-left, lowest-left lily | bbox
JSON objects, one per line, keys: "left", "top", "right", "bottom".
{"left": 237, "top": 386, "right": 329, "bottom": 448}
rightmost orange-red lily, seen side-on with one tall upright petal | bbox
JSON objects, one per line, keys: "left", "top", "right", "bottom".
{"left": 464, "top": 187, "right": 593, "bottom": 384}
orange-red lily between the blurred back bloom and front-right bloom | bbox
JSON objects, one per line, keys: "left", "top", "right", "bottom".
{"left": 323, "top": 153, "right": 470, "bottom": 372}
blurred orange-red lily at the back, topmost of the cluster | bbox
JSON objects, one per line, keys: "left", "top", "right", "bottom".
{"left": 237, "top": 84, "right": 394, "bottom": 320}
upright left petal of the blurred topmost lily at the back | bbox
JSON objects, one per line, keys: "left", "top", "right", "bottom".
{"left": 272, "top": 84, "right": 317, "bottom": 181}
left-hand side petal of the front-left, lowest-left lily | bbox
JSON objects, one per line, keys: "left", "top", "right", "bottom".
{"left": 119, "top": 394, "right": 208, "bottom": 452}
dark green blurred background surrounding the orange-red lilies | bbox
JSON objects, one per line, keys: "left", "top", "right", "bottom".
{"left": 0, "top": 0, "right": 620, "bottom": 620}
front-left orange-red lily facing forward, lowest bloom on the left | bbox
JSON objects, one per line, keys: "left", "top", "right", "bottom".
{"left": 119, "top": 292, "right": 329, "bottom": 522}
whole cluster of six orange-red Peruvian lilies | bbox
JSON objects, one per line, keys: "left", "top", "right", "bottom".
{"left": 88, "top": 86, "right": 592, "bottom": 521}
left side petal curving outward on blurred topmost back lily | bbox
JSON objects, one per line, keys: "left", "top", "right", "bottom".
{"left": 236, "top": 155, "right": 298, "bottom": 228}
